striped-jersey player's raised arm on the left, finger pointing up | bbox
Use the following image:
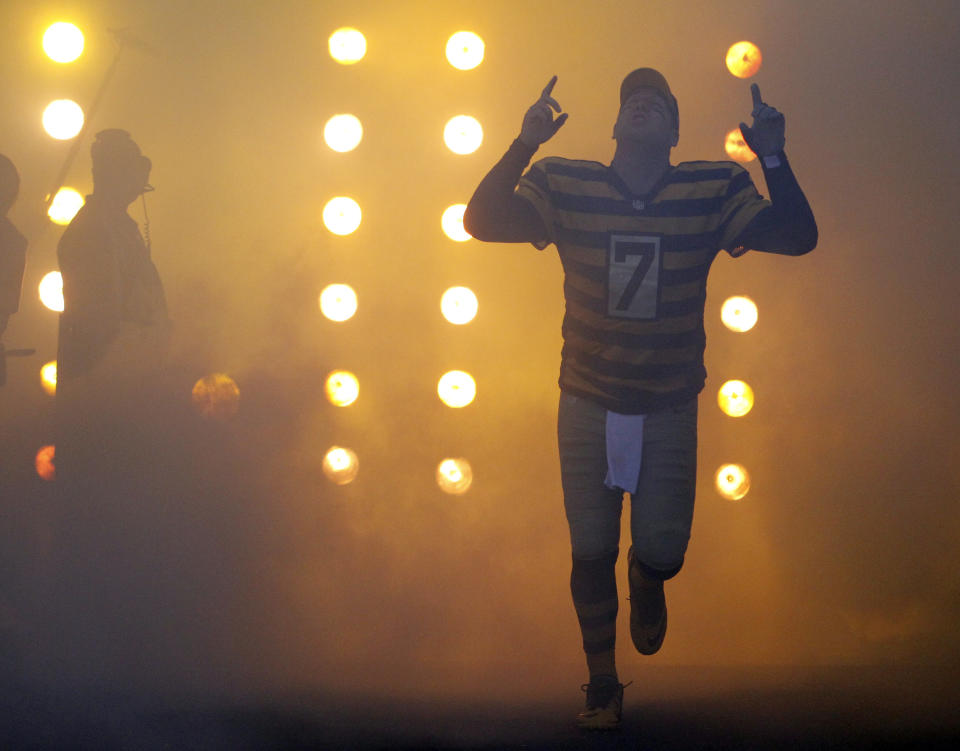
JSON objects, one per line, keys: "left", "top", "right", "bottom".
{"left": 463, "top": 76, "right": 567, "bottom": 242}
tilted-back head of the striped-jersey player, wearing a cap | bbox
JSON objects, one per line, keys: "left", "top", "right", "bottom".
{"left": 613, "top": 68, "right": 680, "bottom": 148}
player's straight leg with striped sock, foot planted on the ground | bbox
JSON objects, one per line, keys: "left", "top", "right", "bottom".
{"left": 557, "top": 393, "right": 623, "bottom": 728}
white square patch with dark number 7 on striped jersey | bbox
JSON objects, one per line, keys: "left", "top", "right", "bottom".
{"left": 607, "top": 235, "right": 660, "bottom": 319}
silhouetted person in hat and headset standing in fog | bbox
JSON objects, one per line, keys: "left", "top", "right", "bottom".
{"left": 56, "top": 130, "right": 169, "bottom": 688}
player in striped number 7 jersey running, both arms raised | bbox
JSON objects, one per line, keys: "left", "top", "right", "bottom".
{"left": 464, "top": 68, "right": 817, "bottom": 728}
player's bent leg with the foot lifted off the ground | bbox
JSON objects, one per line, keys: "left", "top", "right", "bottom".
{"left": 628, "top": 399, "right": 697, "bottom": 654}
